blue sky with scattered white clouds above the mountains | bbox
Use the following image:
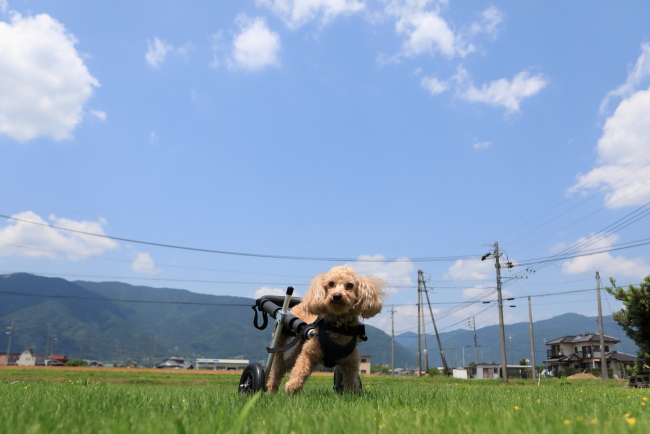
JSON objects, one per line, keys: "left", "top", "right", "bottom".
{"left": 0, "top": 0, "right": 650, "bottom": 332}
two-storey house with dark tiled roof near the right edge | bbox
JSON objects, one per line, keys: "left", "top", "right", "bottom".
{"left": 544, "top": 333, "right": 636, "bottom": 377}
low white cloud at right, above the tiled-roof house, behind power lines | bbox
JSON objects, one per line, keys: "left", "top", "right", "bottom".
{"left": 562, "top": 234, "right": 650, "bottom": 279}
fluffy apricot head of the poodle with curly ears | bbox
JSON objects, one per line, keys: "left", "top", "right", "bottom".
{"left": 303, "top": 265, "right": 386, "bottom": 320}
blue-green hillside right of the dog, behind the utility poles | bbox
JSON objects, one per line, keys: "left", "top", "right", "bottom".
{"left": 395, "top": 313, "right": 638, "bottom": 366}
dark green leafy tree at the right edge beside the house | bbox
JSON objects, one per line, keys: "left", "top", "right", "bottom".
{"left": 605, "top": 276, "right": 650, "bottom": 366}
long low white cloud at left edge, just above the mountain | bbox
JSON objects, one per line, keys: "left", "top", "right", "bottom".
{"left": 0, "top": 211, "right": 118, "bottom": 261}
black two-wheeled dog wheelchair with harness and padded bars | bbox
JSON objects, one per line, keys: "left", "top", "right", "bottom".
{"left": 239, "top": 286, "right": 368, "bottom": 394}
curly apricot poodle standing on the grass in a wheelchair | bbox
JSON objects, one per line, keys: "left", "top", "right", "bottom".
{"left": 266, "top": 265, "right": 386, "bottom": 395}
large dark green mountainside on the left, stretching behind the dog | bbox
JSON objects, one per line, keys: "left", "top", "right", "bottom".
{"left": 0, "top": 273, "right": 415, "bottom": 366}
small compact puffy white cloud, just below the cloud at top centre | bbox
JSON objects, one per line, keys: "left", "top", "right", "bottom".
{"left": 228, "top": 14, "right": 281, "bottom": 70}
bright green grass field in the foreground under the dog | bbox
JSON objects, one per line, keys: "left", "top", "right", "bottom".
{"left": 0, "top": 368, "right": 650, "bottom": 434}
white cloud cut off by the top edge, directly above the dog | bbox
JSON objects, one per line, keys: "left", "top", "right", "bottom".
{"left": 257, "top": 0, "right": 366, "bottom": 29}
